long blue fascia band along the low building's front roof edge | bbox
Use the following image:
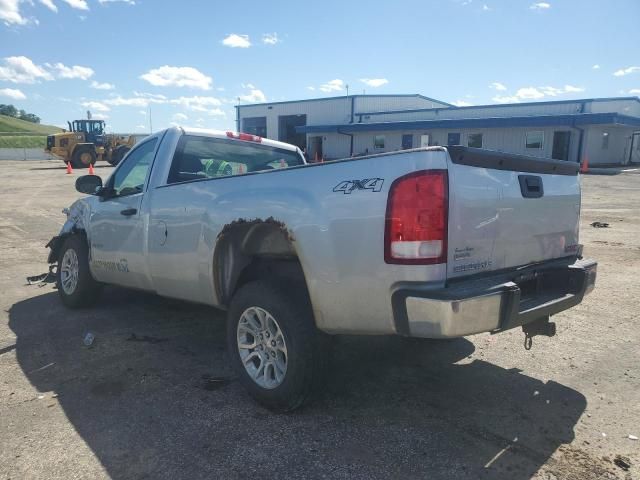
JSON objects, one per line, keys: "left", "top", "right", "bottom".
{"left": 296, "top": 112, "right": 640, "bottom": 133}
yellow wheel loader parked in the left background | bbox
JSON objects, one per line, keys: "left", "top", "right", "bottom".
{"left": 45, "top": 114, "right": 136, "bottom": 168}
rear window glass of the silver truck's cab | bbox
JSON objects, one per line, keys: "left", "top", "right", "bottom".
{"left": 167, "top": 135, "right": 303, "bottom": 183}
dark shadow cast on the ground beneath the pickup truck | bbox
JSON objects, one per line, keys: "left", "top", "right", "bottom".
{"left": 9, "top": 287, "right": 586, "bottom": 479}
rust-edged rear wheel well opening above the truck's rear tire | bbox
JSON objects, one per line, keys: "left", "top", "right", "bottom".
{"left": 213, "top": 218, "right": 306, "bottom": 305}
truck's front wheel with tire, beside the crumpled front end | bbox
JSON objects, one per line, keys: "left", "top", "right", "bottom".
{"left": 56, "top": 235, "right": 101, "bottom": 308}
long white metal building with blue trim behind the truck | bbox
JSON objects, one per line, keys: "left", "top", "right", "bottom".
{"left": 236, "top": 95, "right": 640, "bottom": 165}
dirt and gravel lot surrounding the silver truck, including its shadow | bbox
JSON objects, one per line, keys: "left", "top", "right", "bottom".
{"left": 0, "top": 161, "right": 640, "bottom": 480}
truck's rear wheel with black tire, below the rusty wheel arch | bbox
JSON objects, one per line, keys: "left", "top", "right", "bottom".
{"left": 227, "top": 281, "right": 326, "bottom": 412}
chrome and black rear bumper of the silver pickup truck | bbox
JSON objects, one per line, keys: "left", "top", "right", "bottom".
{"left": 392, "top": 260, "right": 597, "bottom": 338}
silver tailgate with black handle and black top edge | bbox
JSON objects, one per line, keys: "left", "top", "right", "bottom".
{"left": 447, "top": 146, "right": 580, "bottom": 278}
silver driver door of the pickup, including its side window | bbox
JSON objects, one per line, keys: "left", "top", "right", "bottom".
{"left": 89, "top": 138, "right": 158, "bottom": 290}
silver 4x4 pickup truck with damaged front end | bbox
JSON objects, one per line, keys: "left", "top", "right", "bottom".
{"left": 48, "top": 128, "right": 596, "bottom": 411}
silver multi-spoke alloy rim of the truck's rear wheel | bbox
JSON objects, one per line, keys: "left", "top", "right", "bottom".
{"left": 236, "top": 307, "right": 289, "bottom": 390}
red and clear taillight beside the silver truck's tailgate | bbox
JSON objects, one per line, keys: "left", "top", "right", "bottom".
{"left": 384, "top": 170, "right": 449, "bottom": 265}
